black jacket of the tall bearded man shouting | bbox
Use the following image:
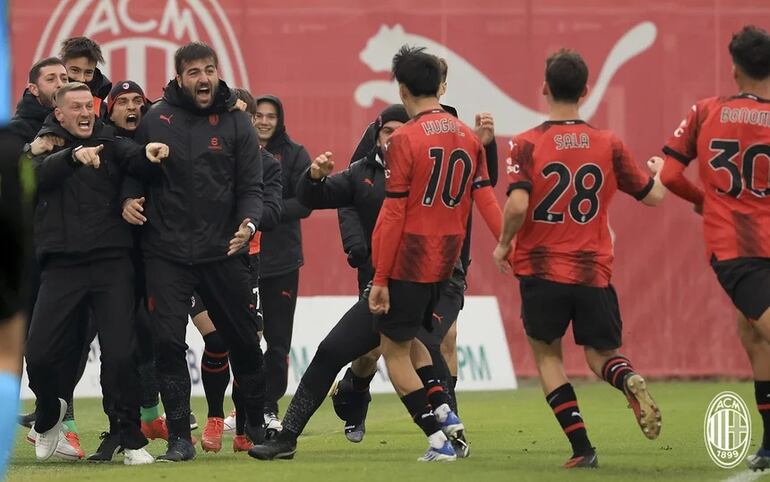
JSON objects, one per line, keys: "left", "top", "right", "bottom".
{"left": 135, "top": 80, "right": 263, "bottom": 264}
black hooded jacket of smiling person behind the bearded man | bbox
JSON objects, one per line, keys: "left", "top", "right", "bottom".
{"left": 257, "top": 95, "right": 310, "bottom": 278}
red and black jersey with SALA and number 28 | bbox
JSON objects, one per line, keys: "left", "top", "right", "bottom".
{"left": 506, "top": 120, "right": 653, "bottom": 287}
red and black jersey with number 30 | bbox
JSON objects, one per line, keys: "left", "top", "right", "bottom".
{"left": 663, "top": 94, "right": 770, "bottom": 261}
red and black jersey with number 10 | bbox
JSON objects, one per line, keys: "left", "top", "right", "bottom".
{"left": 372, "top": 109, "right": 488, "bottom": 286}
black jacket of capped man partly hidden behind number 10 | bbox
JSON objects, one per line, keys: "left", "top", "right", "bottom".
{"left": 297, "top": 151, "right": 385, "bottom": 291}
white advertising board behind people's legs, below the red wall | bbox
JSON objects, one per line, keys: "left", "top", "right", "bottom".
{"left": 22, "top": 296, "right": 517, "bottom": 399}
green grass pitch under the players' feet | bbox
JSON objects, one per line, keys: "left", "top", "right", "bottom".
{"left": 8, "top": 381, "right": 770, "bottom": 482}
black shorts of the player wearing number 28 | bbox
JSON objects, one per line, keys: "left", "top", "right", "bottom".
{"left": 519, "top": 276, "right": 623, "bottom": 350}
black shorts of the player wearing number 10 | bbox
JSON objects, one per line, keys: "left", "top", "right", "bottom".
{"left": 374, "top": 280, "right": 445, "bottom": 341}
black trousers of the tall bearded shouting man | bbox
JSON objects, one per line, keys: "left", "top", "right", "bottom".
{"left": 145, "top": 255, "right": 265, "bottom": 438}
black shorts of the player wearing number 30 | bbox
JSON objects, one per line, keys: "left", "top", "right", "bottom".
{"left": 711, "top": 258, "right": 770, "bottom": 320}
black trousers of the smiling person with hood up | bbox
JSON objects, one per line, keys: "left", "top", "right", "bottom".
{"left": 259, "top": 270, "right": 299, "bottom": 413}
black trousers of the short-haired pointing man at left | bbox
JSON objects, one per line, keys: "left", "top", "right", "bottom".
{"left": 26, "top": 256, "right": 147, "bottom": 449}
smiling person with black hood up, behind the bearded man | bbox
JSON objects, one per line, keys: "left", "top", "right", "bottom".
{"left": 254, "top": 95, "right": 310, "bottom": 437}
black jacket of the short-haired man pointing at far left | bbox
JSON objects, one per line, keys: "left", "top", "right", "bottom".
{"left": 33, "top": 114, "right": 156, "bottom": 264}
